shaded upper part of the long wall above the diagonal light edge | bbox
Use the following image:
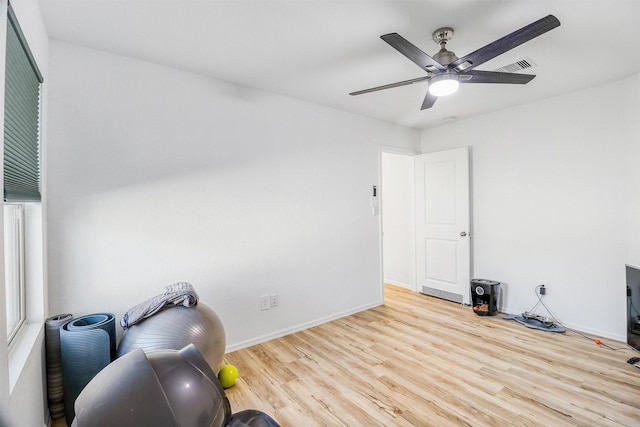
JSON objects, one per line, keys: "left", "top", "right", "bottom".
{"left": 46, "top": 42, "right": 366, "bottom": 199}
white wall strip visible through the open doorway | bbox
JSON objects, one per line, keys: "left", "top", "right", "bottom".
{"left": 381, "top": 153, "right": 415, "bottom": 290}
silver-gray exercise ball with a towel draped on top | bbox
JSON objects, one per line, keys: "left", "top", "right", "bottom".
{"left": 117, "top": 303, "right": 226, "bottom": 374}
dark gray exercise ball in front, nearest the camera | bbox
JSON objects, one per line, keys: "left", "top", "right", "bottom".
{"left": 72, "top": 344, "right": 231, "bottom": 427}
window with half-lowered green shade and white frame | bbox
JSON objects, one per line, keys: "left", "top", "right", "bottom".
{"left": 2, "top": 3, "right": 43, "bottom": 352}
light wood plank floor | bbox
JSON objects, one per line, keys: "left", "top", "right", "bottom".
{"left": 225, "top": 286, "right": 640, "bottom": 427}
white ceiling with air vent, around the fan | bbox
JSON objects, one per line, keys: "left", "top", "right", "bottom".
{"left": 40, "top": 0, "right": 640, "bottom": 129}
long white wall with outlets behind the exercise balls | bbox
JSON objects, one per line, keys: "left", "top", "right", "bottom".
{"left": 47, "top": 42, "right": 419, "bottom": 349}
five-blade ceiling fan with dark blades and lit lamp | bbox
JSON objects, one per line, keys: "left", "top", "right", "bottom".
{"left": 349, "top": 15, "right": 560, "bottom": 110}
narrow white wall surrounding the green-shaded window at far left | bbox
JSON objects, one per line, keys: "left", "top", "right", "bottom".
{"left": 0, "top": 0, "right": 49, "bottom": 427}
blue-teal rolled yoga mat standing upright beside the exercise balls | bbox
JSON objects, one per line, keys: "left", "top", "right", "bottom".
{"left": 60, "top": 313, "right": 116, "bottom": 425}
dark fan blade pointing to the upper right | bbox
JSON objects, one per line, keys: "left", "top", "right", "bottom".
{"left": 449, "top": 15, "right": 560, "bottom": 71}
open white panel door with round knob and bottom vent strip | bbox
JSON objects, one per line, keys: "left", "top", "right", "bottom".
{"left": 415, "top": 147, "right": 471, "bottom": 304}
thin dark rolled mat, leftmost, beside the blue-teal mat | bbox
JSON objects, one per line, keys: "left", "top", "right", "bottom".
{"left": 44, "top": 314, "right": 73, "bottom": 420}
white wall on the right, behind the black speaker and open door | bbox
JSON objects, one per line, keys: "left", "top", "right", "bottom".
{"left": 421, "top": 75, "right": 640, "bottom": 340}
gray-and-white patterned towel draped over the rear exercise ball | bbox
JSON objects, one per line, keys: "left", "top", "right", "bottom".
{"left": 120, "top": 282, "right": 198, "bottom": 330}
